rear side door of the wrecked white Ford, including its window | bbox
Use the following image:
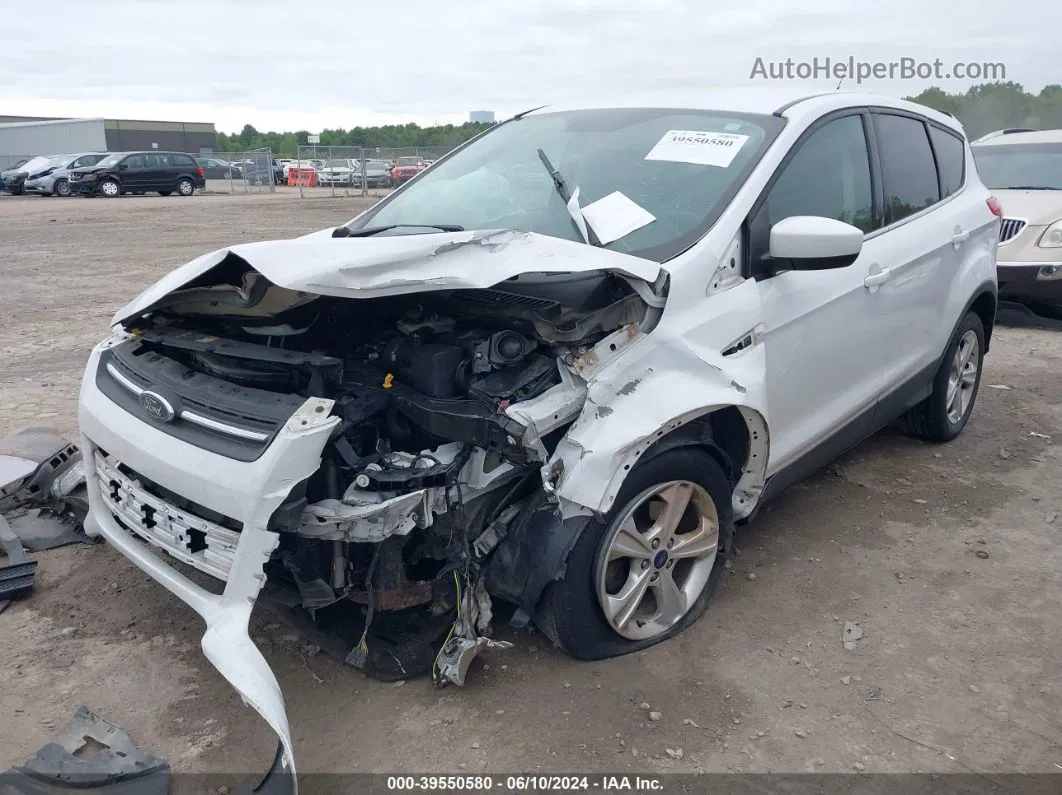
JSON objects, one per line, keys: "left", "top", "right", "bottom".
{"left": 872, "top": 109, "right": 961, "bottom": 397}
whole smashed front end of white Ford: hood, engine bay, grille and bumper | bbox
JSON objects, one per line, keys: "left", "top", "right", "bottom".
{"left": 81, "top": 226, "right": 663, "bottom": 785}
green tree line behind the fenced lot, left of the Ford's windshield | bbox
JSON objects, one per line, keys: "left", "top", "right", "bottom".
{"left": 217, "top": 122, "right": 491, "bottom": 157}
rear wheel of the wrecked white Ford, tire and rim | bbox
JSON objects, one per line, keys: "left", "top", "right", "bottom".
{"left": 904, "top": 312, "right": 984, "bottom": 442}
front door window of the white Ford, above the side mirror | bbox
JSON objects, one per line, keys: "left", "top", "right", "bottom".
{"left": 750, "top": 115, "right": 875, "bottom": 269}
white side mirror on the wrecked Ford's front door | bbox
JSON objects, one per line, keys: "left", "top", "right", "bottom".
{"left": 770, "top": 215, "right": 863, "bottom": 271}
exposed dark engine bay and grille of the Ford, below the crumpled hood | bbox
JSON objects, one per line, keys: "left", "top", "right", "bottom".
{"left": 107, "top": 256, "right": 660, "bottom": 684}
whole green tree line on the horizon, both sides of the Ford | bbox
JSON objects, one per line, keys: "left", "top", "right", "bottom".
{"left": 217, "top": 82, "right": 1062, "bottom": 157}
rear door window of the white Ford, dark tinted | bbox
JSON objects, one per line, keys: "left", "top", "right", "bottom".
{"left": 876, "top": 114, "right": 940, "bottom": 224}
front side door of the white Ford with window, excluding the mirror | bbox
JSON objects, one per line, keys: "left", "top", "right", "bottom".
{"left": 749, "top": 111, "right": 896, "bottom": 477}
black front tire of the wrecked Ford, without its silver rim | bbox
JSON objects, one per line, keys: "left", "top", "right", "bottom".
{"left": 535, "top": 448, "right": 734, "bottom": 660}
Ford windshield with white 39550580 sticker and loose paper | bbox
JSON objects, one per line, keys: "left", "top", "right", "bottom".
{"left": 350, "top": 108, "right": 785, "bottom": 261}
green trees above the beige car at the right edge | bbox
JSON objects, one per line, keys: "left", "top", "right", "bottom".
{"left": 907, "top": 81, "right": 1062, "bottom": 139}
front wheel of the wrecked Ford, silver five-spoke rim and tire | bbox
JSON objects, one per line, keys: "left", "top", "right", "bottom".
{"left": 535, "top": 449, "right": 734, "bottom": 660}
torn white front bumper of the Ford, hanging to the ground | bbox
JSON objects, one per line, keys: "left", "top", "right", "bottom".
{"left": 79, "top": 342, "right": 339, "bottom": 793}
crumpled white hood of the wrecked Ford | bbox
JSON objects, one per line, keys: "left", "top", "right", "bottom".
{"left": 113, "top": 229, "right": 661, "bottom": 324}
